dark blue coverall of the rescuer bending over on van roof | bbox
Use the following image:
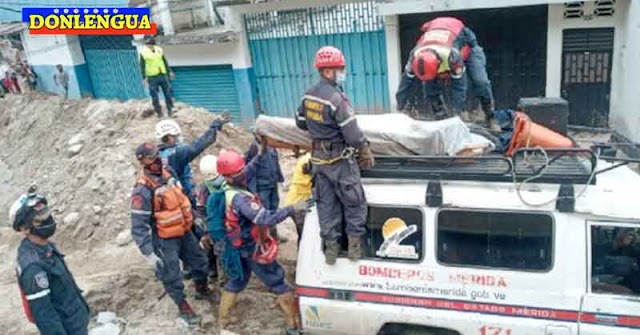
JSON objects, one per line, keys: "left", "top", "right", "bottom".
{"left": 396, "top": 27, "right": 493, "bottom": 111}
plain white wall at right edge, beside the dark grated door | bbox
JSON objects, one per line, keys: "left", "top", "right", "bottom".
{"left": 609, "top": 0, "right": 640, "bottom": 143}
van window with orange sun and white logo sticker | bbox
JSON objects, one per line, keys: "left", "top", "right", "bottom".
{"left": 367, "top": 206, "right": 424, "bottom": 261}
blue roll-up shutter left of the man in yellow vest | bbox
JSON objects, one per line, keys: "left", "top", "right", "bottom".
{"left": 80, "top": 36, "right": 147, "bottom": 100}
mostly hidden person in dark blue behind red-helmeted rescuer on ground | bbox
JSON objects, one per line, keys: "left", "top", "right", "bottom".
{"left": 244, "top": 134, "right": 284, "bottom": 242}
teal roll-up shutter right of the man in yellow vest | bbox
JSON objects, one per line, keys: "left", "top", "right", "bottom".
{"left": 171, "top": 65, "right": 240, "bottom": 122}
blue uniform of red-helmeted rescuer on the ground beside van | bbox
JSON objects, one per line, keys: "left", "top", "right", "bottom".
{"left": 224, "top": 193, "right": 294, "bottom": 295}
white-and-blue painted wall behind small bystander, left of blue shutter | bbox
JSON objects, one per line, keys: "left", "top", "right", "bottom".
{"left": 22, "top": 32, "right": 93, "bottom": 98}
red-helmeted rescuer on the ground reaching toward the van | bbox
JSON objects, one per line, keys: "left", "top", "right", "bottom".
{"left": 217, "top": 151, "right": 311, "bottom": 334}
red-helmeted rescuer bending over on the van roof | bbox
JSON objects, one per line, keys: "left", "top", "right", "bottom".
{"left": 396, "top": 17, "right": 499, "bottom": 130}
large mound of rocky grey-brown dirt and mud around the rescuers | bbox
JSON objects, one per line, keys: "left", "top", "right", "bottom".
{"left": 0, "top": 94, "right": 295, "bottom": 335}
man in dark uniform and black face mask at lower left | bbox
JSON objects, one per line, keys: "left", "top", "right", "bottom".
{"left": 10, "top": 194, "right": 90, "bottom": 335}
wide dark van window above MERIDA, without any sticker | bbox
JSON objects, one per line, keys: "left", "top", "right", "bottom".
{"left": 437, "top": 210, "right": 553, "bottom": 271}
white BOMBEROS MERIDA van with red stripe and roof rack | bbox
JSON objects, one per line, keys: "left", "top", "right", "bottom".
{"left": 296, "top": 146, "right": 640, "bottom": 335}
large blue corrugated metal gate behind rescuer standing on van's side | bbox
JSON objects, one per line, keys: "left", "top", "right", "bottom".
{"left": 245, "top": 2, "right": 390, "bottom": 116}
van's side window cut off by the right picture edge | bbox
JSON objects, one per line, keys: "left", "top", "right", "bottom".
{"left": 591, "top": 226, "right": 640, "bottom": 295}
